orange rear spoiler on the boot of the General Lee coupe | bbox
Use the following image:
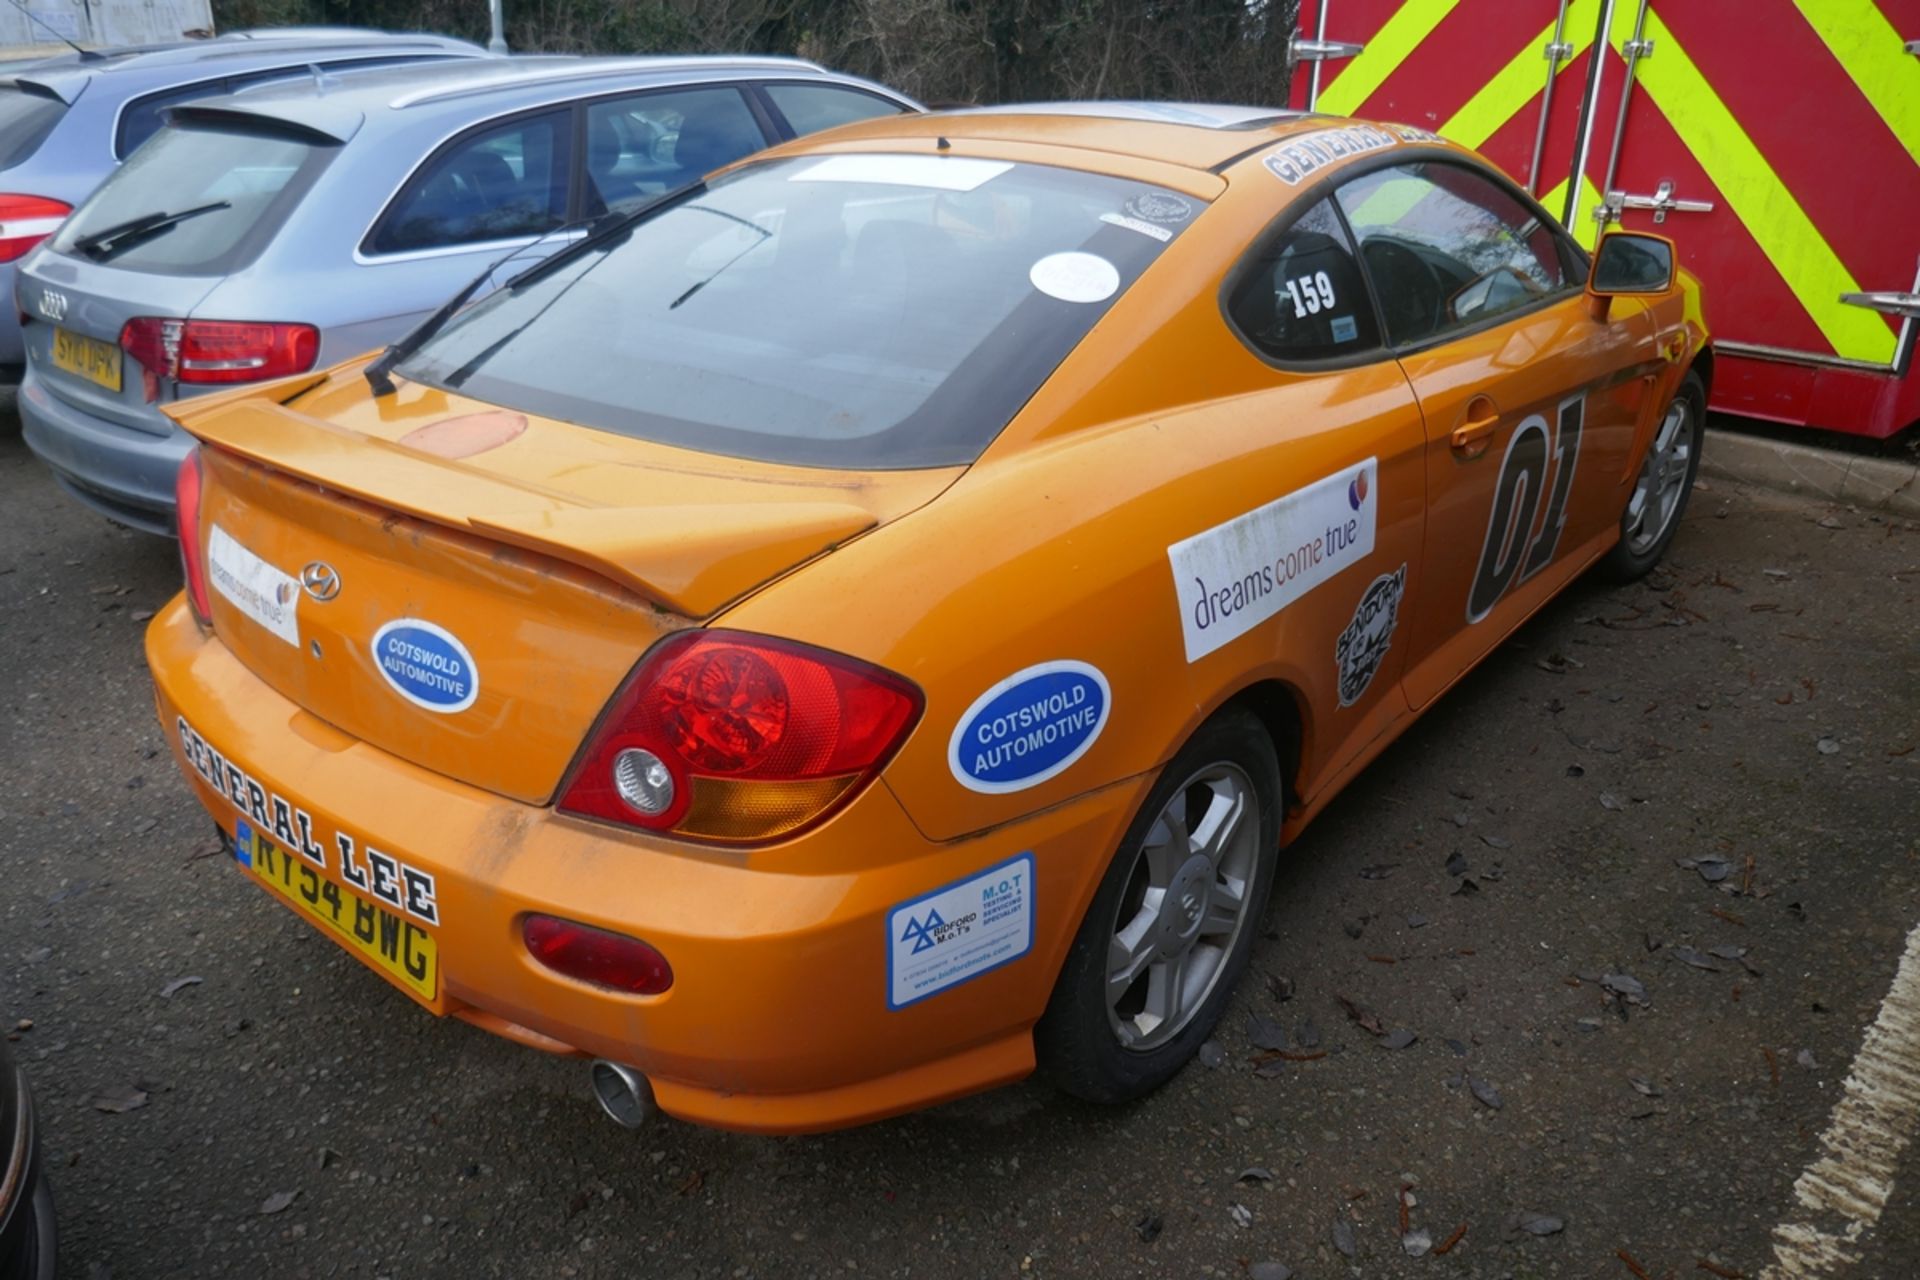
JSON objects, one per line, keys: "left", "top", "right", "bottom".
{"left": 169, "top": 397, "right": 877, "bottom": 618}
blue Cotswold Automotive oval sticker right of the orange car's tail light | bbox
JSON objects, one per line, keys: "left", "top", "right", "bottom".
{"left": 947, "top": 660, "right": 1114, "bottom": 794}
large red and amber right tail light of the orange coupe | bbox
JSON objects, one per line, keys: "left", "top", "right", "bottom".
{"left": 561, "top": 631, "right": 924, "bottom": 844}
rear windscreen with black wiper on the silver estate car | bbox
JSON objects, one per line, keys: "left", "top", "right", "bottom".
{"left": 54, "top": 117, "right": 340, "bottom": 276}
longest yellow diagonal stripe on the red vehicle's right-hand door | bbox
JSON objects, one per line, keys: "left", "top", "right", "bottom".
{"left": 1612, "top": 13, "right": 1893, "bottom": 365}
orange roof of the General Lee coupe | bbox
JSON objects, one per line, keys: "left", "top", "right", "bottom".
{"left": 789, "top": 102, "right": 1357, "bottom": 171}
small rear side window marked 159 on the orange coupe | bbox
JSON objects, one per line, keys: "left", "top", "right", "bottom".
{"left": 1227, "top": 200, "right": 1380, "bottom": 361}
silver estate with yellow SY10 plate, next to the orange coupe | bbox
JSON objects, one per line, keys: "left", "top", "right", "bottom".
{"left": 15, "top": 58, "right": 918, "bottom": 533}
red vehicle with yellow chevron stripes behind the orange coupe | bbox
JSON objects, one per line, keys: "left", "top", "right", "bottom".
{"left": 1292, "top": 0, "right": 1920, "bottom": 438}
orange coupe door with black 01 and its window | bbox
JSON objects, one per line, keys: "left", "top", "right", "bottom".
{"left": 1336, "top": 157, "right": 1657, "bottom": 708}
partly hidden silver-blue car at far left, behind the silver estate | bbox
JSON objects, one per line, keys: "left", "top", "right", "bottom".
{"left": 0, "top": 27, "right": 490, "bottom": 384}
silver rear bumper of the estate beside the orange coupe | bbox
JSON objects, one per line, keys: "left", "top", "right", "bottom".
{"left": 19, "top": 368, "right": 182, "bottom": 537}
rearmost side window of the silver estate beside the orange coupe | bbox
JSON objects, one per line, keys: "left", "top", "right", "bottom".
{"left": 372, "top": 111, "right": 572, "bottom": 253}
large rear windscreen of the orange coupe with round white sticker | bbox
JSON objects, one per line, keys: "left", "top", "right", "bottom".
{"left": 399, "top": 154, "right": 1200, "bottom": 470}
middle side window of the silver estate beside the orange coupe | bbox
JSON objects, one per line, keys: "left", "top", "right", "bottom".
{"left": 588, "top": 86, "right": 766, "bottom": 209}
